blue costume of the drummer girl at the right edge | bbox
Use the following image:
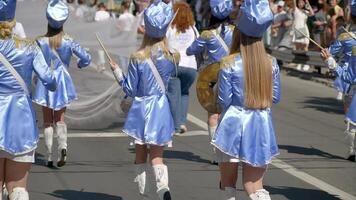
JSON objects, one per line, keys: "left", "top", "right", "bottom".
{"left": 329, "top": 29, "right": 356, "bottom": 94}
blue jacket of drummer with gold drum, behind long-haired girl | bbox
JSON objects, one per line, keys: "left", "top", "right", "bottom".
{"left": 187, "top": 25, "right": 234, "bottom": 64}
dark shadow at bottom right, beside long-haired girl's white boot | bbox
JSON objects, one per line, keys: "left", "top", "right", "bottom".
{"left": 264, "top": 186, "right": 340, "bottom": 200}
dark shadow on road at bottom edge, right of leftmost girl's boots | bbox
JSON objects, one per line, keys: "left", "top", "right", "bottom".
{"left": 48, "top": 190, "right": 123, "bottom": 200}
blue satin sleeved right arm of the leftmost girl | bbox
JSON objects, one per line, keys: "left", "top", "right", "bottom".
{"left": 32, "top": 45, "right": 57, "bottom": 91}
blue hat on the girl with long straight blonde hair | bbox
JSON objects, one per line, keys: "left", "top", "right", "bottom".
{"left": 236, "top": 0, "right": 273, "bottom": 38}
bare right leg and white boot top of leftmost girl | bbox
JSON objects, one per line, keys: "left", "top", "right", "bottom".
{"left": 5, "top": 160, "right": 32, "bottom": 200}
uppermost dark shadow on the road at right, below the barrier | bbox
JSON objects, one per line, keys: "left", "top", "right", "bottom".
{"left": 302, "top": 96, "right": 344, "bottom": 115}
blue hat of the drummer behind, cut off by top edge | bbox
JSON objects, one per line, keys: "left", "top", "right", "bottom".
{"left": 210, "top": 0, "right": 233, "bottom": 19}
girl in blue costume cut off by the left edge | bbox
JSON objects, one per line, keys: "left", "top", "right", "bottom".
{"left": 0, "top": 0, "right": 56, "bottom": 200}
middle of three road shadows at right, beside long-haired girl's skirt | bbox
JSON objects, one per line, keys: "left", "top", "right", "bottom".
{"left": 278, "top": 145, "right": 345, "bottom": 160}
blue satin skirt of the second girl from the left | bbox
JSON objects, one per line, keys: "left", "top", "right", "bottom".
{"left": 33, "top": 66, "right": 77, "bottom": 110}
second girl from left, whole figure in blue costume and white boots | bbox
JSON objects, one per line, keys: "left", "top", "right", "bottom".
{"left": 33, "top": 0, "right": 91, "bottom": 167}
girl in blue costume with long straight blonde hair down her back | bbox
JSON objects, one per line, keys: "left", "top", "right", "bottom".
{"left": 211, "top": 0, "right": 281, "bottom": 200}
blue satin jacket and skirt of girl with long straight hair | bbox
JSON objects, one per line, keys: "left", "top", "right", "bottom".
{"left": 212, "top": 54, "right": 281, "bottom": 167}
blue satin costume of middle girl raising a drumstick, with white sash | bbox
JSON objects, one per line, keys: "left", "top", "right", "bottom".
{"left": 119, "top": 43, "right": 179, "bottom": 146}
